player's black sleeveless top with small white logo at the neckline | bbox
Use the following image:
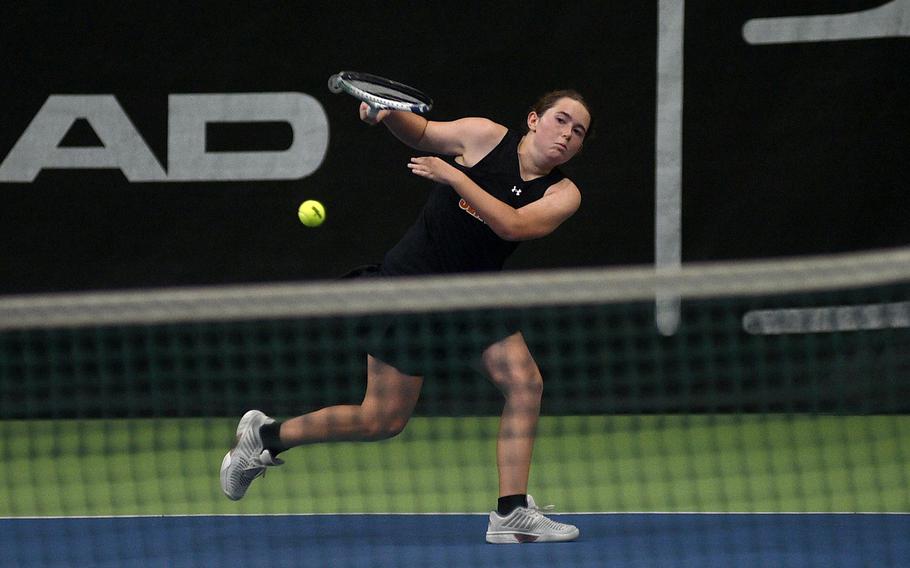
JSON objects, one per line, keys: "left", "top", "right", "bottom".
{"left": 382, "top": 130, "right": 565, "bottom": 276}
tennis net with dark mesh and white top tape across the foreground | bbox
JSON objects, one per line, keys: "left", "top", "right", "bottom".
{"left": 0, "top": 249, "right": 910, "bottom": 566}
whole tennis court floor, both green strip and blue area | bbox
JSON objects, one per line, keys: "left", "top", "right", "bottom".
{"left": 0, "top": 416, "right": 910, "bottom": 568}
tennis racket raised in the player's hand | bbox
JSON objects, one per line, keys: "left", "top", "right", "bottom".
{"left": 329, "top": 71, "right": 433, "bottom": 118}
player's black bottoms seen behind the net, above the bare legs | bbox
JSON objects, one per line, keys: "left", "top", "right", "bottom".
{"left": 341, "top": 264, "right": 521, "bottom": 376}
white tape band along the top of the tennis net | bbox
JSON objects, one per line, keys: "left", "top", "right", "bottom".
{"left": 0, "top": 247, "right": 910, "bottom": 329}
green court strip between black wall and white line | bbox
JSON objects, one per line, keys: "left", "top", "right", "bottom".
{"left": 0, "top": 415, "right": 910, "bottom": 517}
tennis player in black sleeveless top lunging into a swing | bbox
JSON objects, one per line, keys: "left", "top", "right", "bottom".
{"left": 221, "top": 90, "right": 591, "bottom": 543}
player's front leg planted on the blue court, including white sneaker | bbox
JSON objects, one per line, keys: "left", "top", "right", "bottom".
{"left": 483, "top": 333, "right": 578, "bottom": 544}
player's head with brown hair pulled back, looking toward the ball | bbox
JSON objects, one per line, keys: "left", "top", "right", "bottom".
{"left": 528, "top": 97, "right": 591, "bottom": 164}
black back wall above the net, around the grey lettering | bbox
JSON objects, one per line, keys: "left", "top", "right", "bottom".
{"left": 0, "top": 0, "right": 910, "bottom": 293}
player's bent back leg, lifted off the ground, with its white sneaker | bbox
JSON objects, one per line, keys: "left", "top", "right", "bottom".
{"left": 221, "top": 356, "right": 423, "bottom": 500}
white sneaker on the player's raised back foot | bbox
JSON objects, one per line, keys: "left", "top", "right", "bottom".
{"left": 221, "top": 410, "right": 284, "bottom": 501}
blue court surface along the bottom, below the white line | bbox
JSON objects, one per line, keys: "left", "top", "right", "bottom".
{"left": 0, "top": 514, "right": 910, "bottom": 568}
